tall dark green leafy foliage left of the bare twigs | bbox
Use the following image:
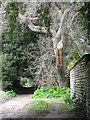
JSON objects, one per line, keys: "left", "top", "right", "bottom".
{"left": 2, "top": 2, "right": 37, "bottom": 89}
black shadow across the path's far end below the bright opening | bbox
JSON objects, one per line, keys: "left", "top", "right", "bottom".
{"left": 15, "top": 87, "right": 37, "bottom": 95}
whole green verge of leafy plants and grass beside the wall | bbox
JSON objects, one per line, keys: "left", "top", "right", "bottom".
{"left": 25, "top": 86, "right": 73, "bottom": 112}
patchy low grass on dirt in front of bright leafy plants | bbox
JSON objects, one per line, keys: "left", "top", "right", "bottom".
{"left": 25, "top": 98, "right": 73, "bottom": 113}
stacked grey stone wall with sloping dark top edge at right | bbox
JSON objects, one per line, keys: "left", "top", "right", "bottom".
{"left": 70, "top": 54, "right": 90, "bottom": 115}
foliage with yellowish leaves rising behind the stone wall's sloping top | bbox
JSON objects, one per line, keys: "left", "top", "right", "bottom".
{"left": 65, "top": 2, "right": 90, "bottom": 77}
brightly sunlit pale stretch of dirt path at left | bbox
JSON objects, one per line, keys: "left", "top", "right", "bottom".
{"left": 0, "top": 94, "right": 32, "bottom": 118}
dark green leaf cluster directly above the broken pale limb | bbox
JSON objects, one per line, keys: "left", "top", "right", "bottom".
{"left": 35, "top": 2, "right": 52, "bottom": 36}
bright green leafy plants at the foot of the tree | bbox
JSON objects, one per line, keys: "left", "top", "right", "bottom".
{"left": 32, "top": 86, "right": 72, "bottom": 103}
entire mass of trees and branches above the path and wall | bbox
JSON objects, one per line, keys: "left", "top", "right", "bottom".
{"left": 1, "top": 2, "right": 90, "bottom": 88}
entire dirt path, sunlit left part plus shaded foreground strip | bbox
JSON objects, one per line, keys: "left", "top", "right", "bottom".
{"left": 0, "top": 94, "right": 75, "bottom": 118}
